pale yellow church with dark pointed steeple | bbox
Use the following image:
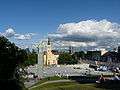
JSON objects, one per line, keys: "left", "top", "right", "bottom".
{"left": 43, "top": 39, "right": 59, "bottom": 66}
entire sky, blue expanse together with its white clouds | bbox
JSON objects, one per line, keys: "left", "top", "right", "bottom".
{"left": 0, "top": 0, "right": 120, "bottom": 48}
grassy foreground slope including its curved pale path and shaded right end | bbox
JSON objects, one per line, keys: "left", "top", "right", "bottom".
{"left": 28, "top": 77, "right": 120, "bottom": 90}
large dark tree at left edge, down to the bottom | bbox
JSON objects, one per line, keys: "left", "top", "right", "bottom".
{"left": 0, "top": 37, "right": 27, "bottom": 90}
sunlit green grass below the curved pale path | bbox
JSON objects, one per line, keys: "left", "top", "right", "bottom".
{"left": 30, "top": 82, "right": 106, "bottom": 90}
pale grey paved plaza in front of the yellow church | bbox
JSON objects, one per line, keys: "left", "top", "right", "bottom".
{"left": 27, "top": 64, "right": 113, "bottom": 77}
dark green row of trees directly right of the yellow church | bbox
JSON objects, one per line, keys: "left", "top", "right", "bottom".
{"left": 58, "top": 51, "right": 101, "bottom": 64}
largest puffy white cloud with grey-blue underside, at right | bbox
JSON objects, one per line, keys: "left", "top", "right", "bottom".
{"left": 49, "top": 20, "right": 120, "bottom": 47}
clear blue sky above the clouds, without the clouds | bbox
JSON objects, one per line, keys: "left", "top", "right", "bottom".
{"left": 0, "top": 0, "right": 120, "bottom": 48}
